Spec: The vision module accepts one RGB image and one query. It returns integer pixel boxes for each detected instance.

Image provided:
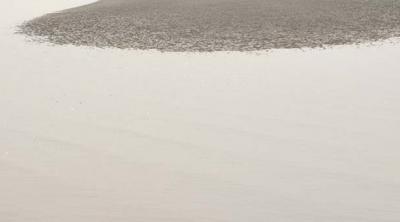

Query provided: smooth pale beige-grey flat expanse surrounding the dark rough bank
[0,0,400,222]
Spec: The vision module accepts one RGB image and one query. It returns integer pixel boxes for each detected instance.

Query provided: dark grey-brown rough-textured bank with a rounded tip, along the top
[20,0,400,51]
